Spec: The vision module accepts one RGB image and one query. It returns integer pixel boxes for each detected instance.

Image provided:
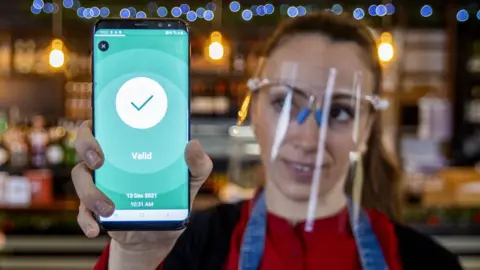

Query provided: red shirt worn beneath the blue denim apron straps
[94,203,402,270]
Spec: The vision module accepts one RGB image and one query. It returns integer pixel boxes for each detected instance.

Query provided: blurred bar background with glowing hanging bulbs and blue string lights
[0,0,480,270]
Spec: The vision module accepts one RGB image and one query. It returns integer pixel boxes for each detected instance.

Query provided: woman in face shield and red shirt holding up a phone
[72,13,461,270]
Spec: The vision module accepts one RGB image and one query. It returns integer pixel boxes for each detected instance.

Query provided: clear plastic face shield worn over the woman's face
[229,59,388,231]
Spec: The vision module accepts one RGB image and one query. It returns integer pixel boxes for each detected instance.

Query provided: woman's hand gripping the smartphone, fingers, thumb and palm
[72,121,213,243]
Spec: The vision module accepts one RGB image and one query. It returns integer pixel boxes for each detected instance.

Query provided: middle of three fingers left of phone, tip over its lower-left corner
[72,162,115,217]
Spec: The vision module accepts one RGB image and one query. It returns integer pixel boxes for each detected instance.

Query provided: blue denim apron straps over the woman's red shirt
[238,192,388,270]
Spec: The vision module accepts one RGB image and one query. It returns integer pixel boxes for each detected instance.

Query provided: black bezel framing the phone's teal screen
[91,18,192,231]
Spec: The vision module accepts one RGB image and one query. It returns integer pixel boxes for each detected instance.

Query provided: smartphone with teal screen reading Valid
[92,19,190,231]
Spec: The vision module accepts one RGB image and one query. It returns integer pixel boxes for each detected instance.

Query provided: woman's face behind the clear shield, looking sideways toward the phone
[251,34,374,201]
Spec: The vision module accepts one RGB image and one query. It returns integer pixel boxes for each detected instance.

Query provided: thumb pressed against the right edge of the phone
[185,140,213,197]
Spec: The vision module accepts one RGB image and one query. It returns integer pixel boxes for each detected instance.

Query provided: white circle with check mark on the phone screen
[116,77,168,129]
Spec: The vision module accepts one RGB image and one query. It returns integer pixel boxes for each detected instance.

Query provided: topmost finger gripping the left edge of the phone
[75,121,103,170]
